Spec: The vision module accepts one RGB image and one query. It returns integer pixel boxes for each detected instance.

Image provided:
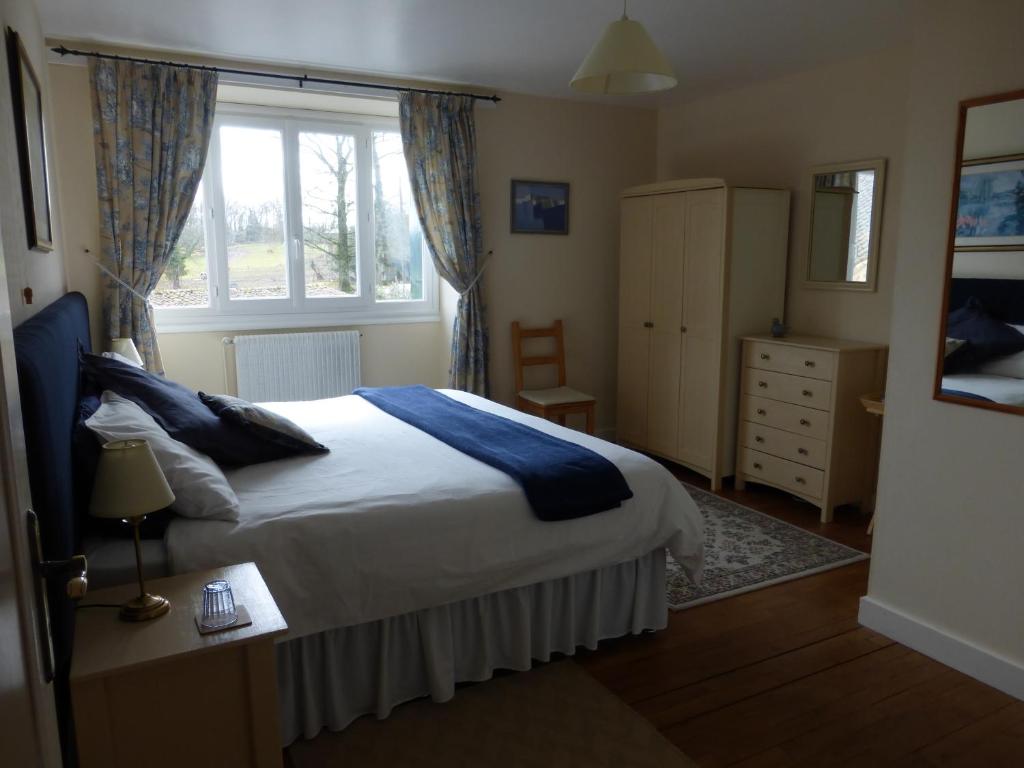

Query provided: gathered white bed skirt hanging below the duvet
[278,549,668,744]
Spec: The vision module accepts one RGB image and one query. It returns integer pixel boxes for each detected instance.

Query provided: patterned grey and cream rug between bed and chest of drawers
[666,483,868,610]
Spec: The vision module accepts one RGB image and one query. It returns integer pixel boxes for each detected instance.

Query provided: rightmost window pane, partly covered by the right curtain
[371,131,424,301]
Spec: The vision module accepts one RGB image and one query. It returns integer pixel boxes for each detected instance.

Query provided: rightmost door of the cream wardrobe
[677,189,725,471]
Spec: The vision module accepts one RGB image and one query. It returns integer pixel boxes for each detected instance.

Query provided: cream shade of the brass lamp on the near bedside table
[89,440,174,519]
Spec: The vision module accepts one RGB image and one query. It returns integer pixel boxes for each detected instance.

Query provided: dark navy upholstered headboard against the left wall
[14,293,90,696]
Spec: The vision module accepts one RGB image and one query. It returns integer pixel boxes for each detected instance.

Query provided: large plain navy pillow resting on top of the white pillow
[80,353,292,467]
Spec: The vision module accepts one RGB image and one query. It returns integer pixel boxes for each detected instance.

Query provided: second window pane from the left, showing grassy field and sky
[220,125,288,299]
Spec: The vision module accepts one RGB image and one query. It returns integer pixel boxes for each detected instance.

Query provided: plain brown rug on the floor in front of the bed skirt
[285,659,696,768]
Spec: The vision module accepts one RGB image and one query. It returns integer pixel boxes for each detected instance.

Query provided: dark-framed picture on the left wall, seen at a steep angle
[7,27,53,251]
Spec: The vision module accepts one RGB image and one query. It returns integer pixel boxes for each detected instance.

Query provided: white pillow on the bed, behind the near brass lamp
[85,391,239,520]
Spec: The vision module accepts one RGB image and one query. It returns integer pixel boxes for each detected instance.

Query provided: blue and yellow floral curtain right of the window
[399,92,489,397]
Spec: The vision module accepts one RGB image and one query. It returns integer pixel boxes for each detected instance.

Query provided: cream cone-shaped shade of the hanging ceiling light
[569,14,678,94]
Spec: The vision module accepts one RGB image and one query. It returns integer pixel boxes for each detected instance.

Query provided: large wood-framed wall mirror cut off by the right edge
[935,91,1024,414]
